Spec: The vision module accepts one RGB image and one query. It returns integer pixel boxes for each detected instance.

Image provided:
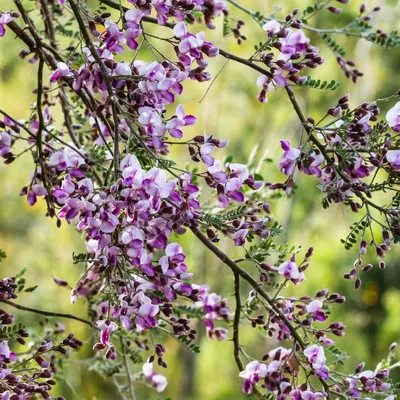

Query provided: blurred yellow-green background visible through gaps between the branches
[0,0,400,400]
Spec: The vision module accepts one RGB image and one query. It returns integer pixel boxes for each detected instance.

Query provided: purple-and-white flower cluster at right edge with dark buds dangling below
[270,95,400,282]
